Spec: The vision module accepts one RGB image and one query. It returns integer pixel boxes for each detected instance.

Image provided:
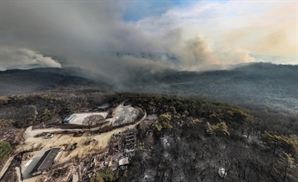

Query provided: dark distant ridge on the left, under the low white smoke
[0,68,94,96]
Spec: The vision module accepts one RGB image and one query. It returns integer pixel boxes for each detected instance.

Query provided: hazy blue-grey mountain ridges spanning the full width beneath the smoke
[0,63,298,112]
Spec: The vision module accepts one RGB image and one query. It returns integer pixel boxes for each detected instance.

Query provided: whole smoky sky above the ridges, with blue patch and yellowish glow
[0,0,297,75]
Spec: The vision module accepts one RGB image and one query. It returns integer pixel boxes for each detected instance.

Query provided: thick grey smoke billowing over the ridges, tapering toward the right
[0,1,254,78]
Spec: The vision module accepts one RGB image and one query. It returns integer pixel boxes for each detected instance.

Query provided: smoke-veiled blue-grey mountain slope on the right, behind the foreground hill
[121,63,298,113]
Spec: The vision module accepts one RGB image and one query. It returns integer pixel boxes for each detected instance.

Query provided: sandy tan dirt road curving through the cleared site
[24,104,147,163]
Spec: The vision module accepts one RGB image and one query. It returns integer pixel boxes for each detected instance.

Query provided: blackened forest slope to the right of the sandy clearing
[114,94,298,182]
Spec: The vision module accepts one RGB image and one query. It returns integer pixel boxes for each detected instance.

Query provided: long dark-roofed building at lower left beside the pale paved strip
[30,148,60,176]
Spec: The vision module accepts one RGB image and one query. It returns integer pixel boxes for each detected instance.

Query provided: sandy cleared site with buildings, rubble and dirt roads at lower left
[0,103,147,182]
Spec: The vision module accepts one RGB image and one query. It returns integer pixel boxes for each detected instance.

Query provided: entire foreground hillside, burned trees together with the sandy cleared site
[1,92,298,182]
